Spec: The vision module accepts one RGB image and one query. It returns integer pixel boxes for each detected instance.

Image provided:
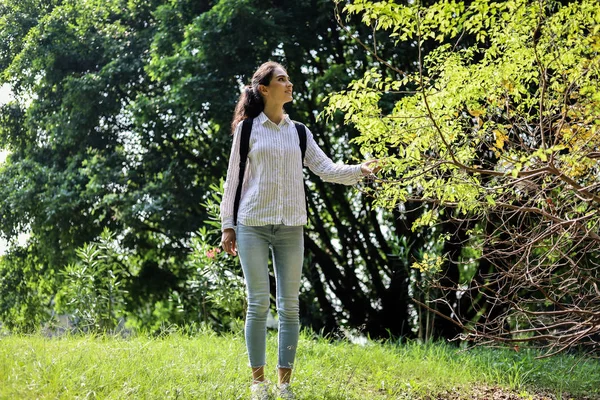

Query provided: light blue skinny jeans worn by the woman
[236,225,304,368]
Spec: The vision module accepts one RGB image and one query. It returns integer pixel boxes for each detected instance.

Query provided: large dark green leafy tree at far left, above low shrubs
[0,1,213,330]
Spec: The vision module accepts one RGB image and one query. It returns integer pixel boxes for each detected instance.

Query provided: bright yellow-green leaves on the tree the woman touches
[326,0,600,225]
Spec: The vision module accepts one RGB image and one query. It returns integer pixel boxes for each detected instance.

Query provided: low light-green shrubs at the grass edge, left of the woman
[49,185,245,332]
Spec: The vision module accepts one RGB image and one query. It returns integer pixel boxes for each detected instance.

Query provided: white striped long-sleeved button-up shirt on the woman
[221,113,362,230]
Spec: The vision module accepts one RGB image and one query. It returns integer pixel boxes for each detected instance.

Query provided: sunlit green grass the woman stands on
[0,333,600,400]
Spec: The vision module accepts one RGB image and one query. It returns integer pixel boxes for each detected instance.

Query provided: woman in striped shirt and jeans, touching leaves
[221,62,379,399]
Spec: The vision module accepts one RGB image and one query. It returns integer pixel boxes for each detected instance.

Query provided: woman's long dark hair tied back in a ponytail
[231,61,285,133]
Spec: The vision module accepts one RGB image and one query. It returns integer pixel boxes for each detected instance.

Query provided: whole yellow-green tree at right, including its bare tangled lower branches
[327,0,600,351]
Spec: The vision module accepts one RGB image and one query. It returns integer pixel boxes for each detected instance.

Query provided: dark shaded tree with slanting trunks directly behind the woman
[153,1,422,337]
